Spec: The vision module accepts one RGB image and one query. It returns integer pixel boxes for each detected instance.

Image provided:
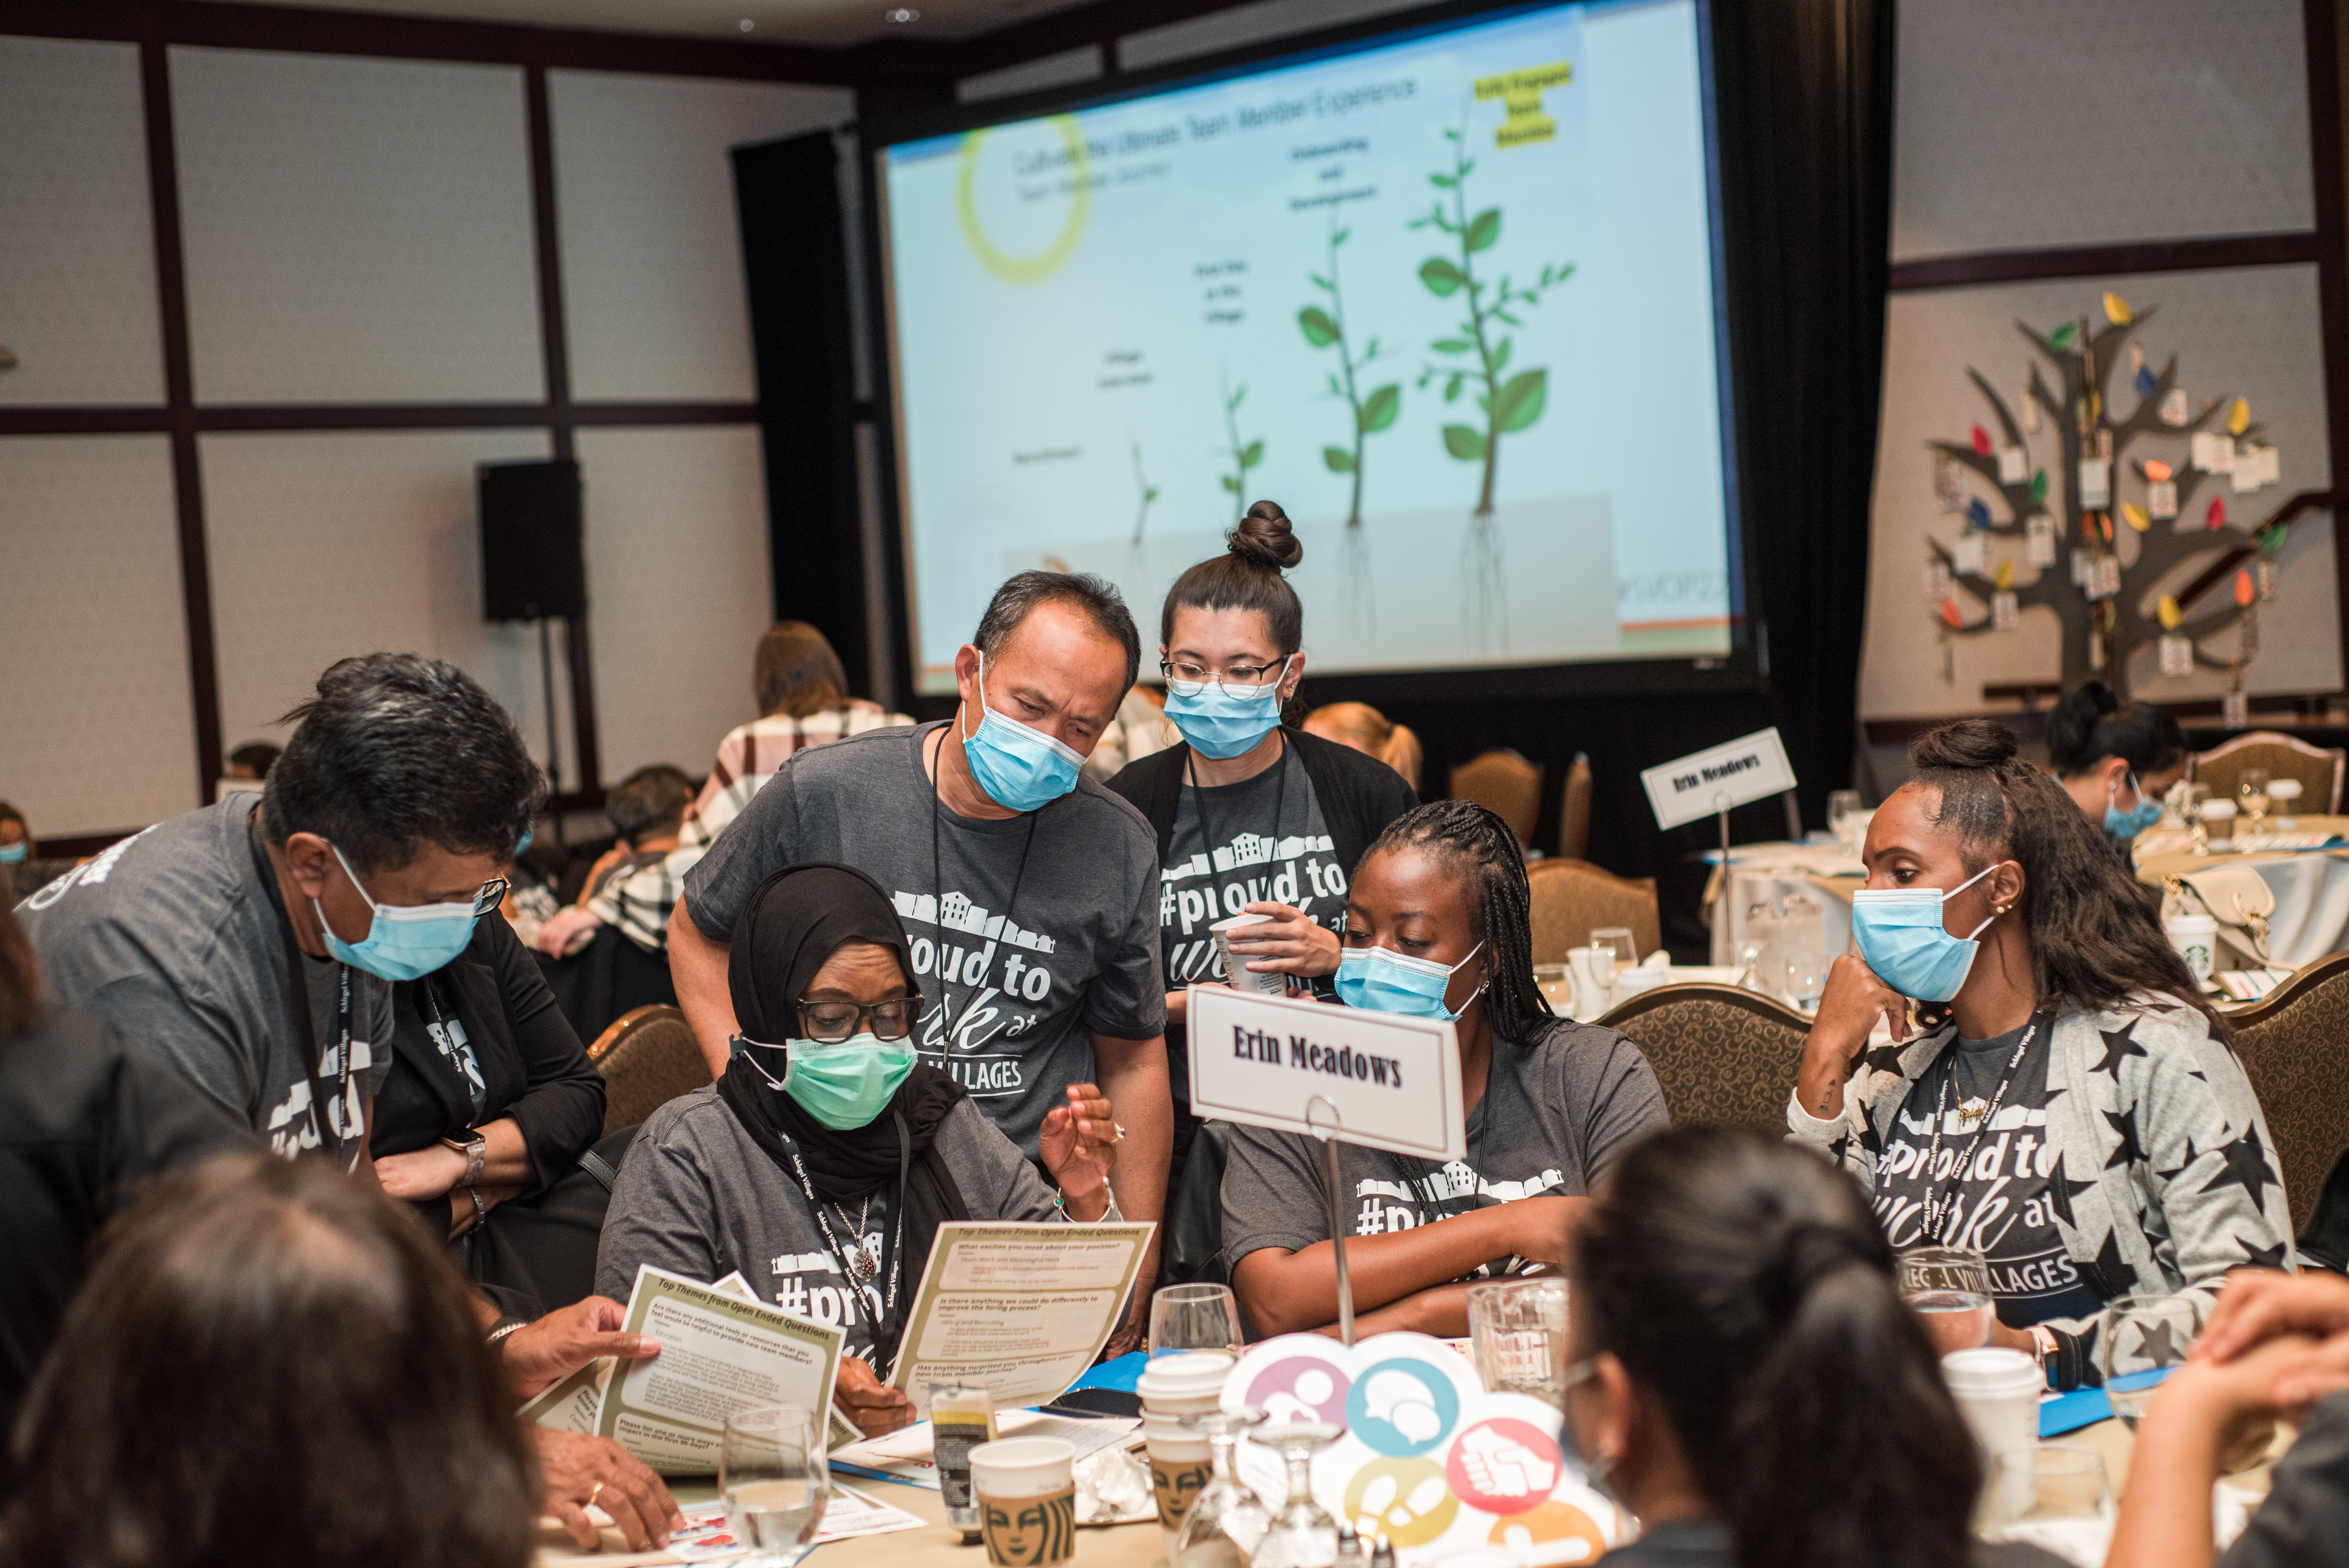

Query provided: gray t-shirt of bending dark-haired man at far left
[16,793,392,1162]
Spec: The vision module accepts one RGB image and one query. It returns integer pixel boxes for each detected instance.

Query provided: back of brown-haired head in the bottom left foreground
[0,1155,540,1568]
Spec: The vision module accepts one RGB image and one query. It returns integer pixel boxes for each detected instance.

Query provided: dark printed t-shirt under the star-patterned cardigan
[1877,1023,2105,1329]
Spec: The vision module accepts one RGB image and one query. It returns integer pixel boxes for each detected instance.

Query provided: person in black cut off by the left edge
[0,904,251,1498]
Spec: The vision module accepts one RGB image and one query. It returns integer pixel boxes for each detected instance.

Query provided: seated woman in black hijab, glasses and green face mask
[597,861,1121,1436]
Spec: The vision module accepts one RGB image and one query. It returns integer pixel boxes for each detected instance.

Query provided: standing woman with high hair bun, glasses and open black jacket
[1109,500,1419,1192]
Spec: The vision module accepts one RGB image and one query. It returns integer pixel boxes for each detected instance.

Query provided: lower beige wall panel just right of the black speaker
[578,427,775,784]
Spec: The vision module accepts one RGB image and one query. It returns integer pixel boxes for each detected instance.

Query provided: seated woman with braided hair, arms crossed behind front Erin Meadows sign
[1224,800,1668,1336]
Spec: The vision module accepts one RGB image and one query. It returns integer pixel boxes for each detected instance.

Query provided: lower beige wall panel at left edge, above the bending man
[0,437,197,838]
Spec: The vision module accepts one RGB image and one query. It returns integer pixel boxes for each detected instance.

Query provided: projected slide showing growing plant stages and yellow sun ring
[879,0,1734,693]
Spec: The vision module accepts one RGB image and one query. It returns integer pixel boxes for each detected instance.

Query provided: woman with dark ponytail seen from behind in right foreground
[1565,1127,2058,1568]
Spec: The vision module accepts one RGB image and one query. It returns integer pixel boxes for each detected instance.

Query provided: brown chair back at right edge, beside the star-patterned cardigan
[2231,953,2349,1232]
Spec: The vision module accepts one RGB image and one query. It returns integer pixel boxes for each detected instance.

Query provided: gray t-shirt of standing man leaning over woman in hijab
[686,725,1165,1155]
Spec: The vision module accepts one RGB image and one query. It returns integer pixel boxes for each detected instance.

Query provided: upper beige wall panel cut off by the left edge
[0,37,162,406]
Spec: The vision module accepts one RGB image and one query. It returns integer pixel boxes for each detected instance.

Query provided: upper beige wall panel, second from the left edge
[171,47,545,404]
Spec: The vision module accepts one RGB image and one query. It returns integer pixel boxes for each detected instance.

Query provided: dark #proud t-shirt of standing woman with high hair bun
[1158,747,1346,1106]
